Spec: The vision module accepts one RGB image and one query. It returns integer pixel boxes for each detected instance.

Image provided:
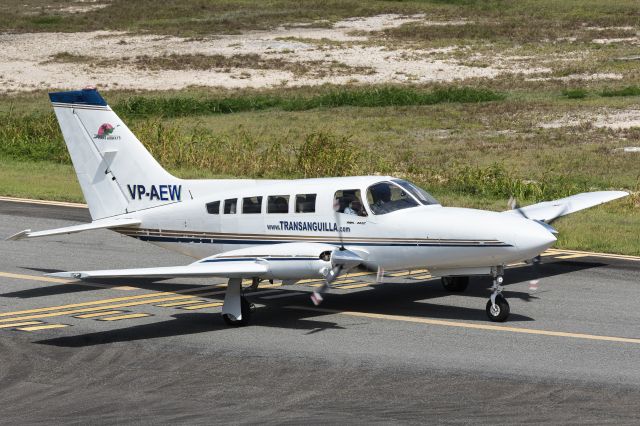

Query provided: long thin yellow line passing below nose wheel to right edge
[287,306,640,344]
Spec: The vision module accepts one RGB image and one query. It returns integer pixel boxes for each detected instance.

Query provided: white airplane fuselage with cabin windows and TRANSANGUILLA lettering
[118,176,555,274]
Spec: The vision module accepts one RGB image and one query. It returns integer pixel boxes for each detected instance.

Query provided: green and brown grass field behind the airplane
[0,0,640,255]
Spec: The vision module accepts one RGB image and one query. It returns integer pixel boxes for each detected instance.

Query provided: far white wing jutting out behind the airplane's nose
[504,191,629,223]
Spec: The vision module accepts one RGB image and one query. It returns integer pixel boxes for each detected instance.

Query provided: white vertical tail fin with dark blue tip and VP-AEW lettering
[49,89,185,220]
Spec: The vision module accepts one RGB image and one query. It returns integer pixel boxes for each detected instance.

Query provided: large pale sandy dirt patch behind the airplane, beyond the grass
[0,13,628,93]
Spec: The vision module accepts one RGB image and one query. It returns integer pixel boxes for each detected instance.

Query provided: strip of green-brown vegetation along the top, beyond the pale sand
[0,0,640,36]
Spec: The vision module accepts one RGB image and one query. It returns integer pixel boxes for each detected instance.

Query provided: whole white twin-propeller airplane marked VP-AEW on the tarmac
[9,88,628,325]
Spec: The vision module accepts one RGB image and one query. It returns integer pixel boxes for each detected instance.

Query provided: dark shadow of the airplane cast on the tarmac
[23,262,602,347]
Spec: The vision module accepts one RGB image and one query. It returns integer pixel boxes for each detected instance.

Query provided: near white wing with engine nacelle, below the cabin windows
[47,243,364,280]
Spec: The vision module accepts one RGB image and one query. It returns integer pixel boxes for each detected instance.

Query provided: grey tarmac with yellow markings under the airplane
[0,200,640,425]
